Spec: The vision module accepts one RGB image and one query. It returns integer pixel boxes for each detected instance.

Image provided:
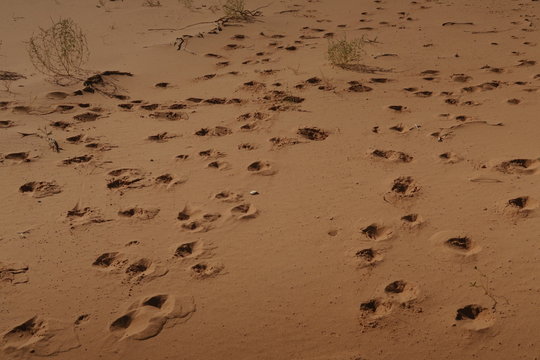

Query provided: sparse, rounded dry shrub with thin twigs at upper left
[28,19,89,82]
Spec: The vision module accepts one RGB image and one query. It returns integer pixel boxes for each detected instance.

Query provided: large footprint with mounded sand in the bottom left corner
[1,316,80,358]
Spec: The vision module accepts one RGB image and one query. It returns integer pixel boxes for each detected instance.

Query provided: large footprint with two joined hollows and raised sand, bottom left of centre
[109,294,195,341]
